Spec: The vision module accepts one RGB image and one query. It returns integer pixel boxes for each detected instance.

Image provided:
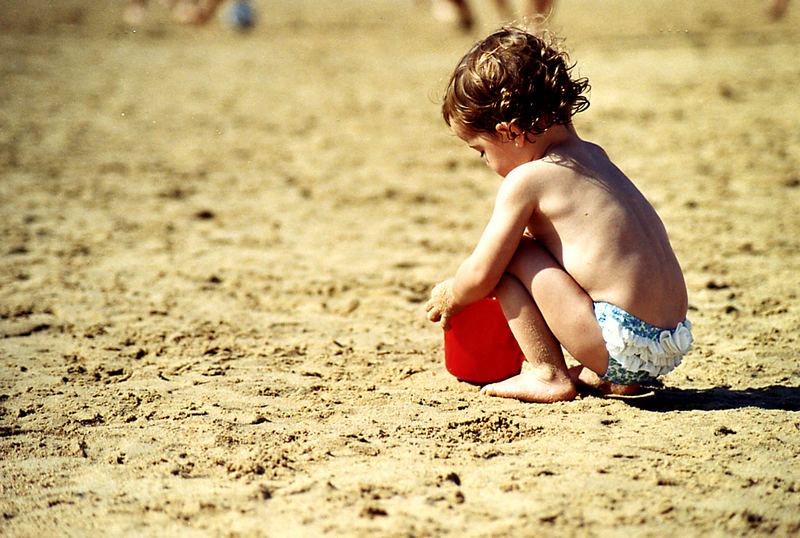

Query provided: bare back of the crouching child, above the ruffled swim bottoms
[519,132,688,329]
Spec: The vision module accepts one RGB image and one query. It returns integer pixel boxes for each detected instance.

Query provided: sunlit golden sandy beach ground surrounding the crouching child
[0,0,800,537]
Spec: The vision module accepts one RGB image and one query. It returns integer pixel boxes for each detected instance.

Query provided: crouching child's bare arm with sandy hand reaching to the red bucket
[426,168,536,329]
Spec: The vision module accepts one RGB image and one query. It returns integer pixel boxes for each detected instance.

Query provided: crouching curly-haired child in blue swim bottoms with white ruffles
[426,28,692,402]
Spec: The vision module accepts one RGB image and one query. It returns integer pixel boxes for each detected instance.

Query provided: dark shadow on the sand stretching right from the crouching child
[627,385,800,412]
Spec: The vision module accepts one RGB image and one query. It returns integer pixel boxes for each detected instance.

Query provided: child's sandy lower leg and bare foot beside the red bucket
[481,274,577,402]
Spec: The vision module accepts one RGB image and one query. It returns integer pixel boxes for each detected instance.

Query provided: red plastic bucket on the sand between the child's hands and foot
[444,297,525,384]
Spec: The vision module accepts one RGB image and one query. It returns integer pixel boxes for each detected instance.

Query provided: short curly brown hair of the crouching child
[442,28,590,135]
